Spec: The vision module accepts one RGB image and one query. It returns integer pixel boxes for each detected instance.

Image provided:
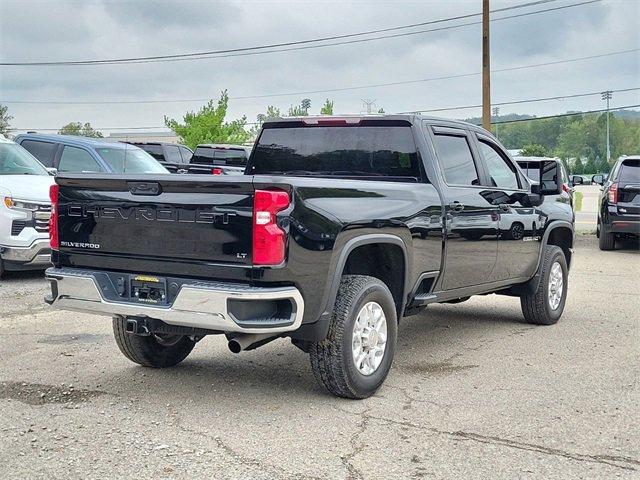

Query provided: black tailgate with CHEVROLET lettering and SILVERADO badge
[57,175,253,265]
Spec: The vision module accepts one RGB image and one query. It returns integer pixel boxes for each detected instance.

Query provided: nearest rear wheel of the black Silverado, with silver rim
[309,275,398,399]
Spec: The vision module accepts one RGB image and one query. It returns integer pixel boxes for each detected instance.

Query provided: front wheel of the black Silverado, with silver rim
[520,245,569,325]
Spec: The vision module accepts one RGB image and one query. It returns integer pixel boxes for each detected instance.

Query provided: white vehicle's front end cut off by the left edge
[0,135,54,275]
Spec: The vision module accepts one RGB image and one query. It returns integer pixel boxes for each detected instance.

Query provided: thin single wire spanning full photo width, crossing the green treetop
[0,48,640,105]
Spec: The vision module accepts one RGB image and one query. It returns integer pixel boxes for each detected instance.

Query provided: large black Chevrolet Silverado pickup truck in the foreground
[46,115,574,398]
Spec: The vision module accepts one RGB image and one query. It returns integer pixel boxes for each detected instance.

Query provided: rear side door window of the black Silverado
[434,132,480,186]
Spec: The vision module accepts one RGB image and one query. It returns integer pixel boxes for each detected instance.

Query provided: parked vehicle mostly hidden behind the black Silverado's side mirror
[515,157,582,207]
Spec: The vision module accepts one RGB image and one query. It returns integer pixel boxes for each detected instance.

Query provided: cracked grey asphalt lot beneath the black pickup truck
[0,236,640,479]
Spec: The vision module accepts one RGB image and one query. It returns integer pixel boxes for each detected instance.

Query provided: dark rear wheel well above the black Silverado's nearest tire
[342,243,405,319]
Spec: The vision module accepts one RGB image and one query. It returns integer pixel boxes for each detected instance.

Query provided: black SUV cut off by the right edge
[591,155,640,250]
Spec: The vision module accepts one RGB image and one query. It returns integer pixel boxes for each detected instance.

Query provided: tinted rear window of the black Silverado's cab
[250,125,421,181]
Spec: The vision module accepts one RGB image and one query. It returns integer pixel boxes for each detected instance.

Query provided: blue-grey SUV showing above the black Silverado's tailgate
[15,133,169,174]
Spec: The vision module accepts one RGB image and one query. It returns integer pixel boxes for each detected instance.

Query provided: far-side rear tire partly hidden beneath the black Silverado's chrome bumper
[113,317,195,368]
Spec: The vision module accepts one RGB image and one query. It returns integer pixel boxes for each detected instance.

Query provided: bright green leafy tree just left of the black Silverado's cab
[164,90,251,148]
